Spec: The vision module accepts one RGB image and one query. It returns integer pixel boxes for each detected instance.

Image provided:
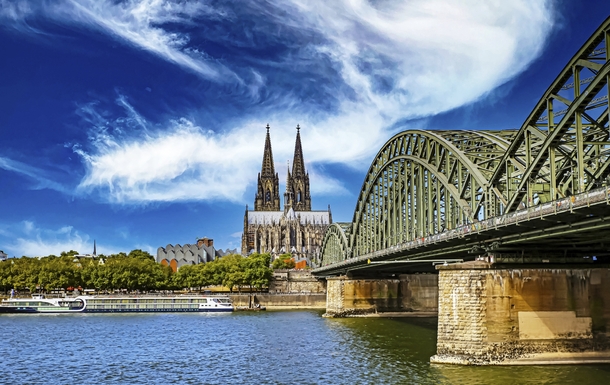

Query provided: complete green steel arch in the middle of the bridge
[342,130,511,263]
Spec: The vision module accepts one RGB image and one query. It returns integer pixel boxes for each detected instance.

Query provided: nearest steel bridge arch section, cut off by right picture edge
[489,18,610,213]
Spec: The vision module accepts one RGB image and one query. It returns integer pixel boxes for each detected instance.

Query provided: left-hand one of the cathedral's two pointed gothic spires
[254,124,280,211]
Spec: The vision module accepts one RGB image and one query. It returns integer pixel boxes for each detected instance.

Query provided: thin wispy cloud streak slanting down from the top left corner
[0,0,241,82]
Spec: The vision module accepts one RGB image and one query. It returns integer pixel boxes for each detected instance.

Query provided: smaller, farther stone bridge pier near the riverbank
[325,274,438,317]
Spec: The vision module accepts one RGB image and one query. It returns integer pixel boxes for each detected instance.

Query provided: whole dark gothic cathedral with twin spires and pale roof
[241,125,332,268]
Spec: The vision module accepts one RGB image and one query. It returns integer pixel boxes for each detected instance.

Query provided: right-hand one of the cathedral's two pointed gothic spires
[284,124,311,211]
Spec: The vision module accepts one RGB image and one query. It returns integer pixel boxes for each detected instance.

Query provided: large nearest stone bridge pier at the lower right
[430,261,610,365]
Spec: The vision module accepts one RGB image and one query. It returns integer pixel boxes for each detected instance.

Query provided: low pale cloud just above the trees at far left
[0,221,119,257]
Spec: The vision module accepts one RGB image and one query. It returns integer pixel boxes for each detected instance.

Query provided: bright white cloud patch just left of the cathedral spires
[75,112,260,203]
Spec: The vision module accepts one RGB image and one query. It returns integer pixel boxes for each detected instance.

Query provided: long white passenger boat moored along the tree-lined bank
[0,295,233,314]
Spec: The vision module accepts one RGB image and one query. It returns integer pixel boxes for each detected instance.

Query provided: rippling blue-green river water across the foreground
[0,311,610,385]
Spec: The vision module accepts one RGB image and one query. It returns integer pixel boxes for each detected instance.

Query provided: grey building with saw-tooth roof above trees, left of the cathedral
[157,238,237,272]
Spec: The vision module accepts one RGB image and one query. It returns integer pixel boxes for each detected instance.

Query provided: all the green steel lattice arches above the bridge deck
[322,18,610,265]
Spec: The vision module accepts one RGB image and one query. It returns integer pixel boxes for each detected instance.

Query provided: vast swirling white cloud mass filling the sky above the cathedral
[5,0,554,204]
